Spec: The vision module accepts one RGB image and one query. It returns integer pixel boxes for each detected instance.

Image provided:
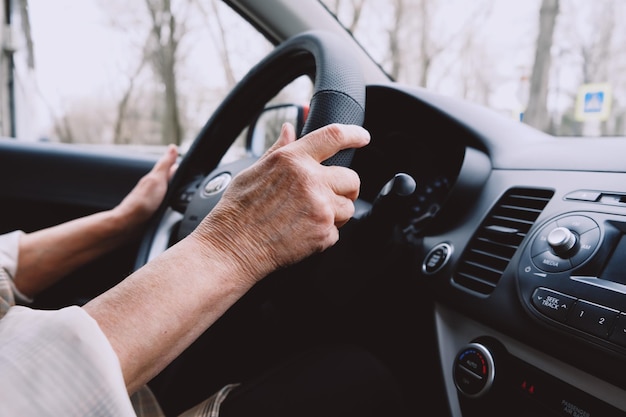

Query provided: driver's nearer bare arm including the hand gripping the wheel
[83,121,369,392]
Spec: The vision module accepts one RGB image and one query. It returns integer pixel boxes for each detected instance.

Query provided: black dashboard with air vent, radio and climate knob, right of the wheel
[353,85,626,416]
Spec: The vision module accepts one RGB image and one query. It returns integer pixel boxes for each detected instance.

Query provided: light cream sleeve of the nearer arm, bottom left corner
[0,306,136,417]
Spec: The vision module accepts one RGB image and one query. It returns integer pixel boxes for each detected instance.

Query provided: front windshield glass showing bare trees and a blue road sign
[321,0,626,136]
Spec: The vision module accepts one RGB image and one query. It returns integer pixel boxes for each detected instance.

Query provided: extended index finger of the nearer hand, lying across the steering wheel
[296,123,370,162]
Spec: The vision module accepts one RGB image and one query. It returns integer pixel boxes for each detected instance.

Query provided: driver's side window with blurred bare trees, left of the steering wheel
[0,0,290,156]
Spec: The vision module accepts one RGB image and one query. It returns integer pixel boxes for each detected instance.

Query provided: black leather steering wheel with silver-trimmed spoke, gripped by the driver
[135,31,365,268]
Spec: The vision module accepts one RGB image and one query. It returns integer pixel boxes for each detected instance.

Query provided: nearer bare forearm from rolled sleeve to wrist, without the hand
[83,234,252,392]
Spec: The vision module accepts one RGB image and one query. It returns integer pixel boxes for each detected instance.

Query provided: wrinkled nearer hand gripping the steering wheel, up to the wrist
[192,124,370,281]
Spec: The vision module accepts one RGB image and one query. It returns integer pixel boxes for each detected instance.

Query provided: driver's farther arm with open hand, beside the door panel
[14,146,177,297]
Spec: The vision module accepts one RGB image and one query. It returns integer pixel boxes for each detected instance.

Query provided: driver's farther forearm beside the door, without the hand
[14,209,143,297]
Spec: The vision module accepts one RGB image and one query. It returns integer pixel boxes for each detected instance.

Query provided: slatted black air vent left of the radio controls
[454,188,554,295]
